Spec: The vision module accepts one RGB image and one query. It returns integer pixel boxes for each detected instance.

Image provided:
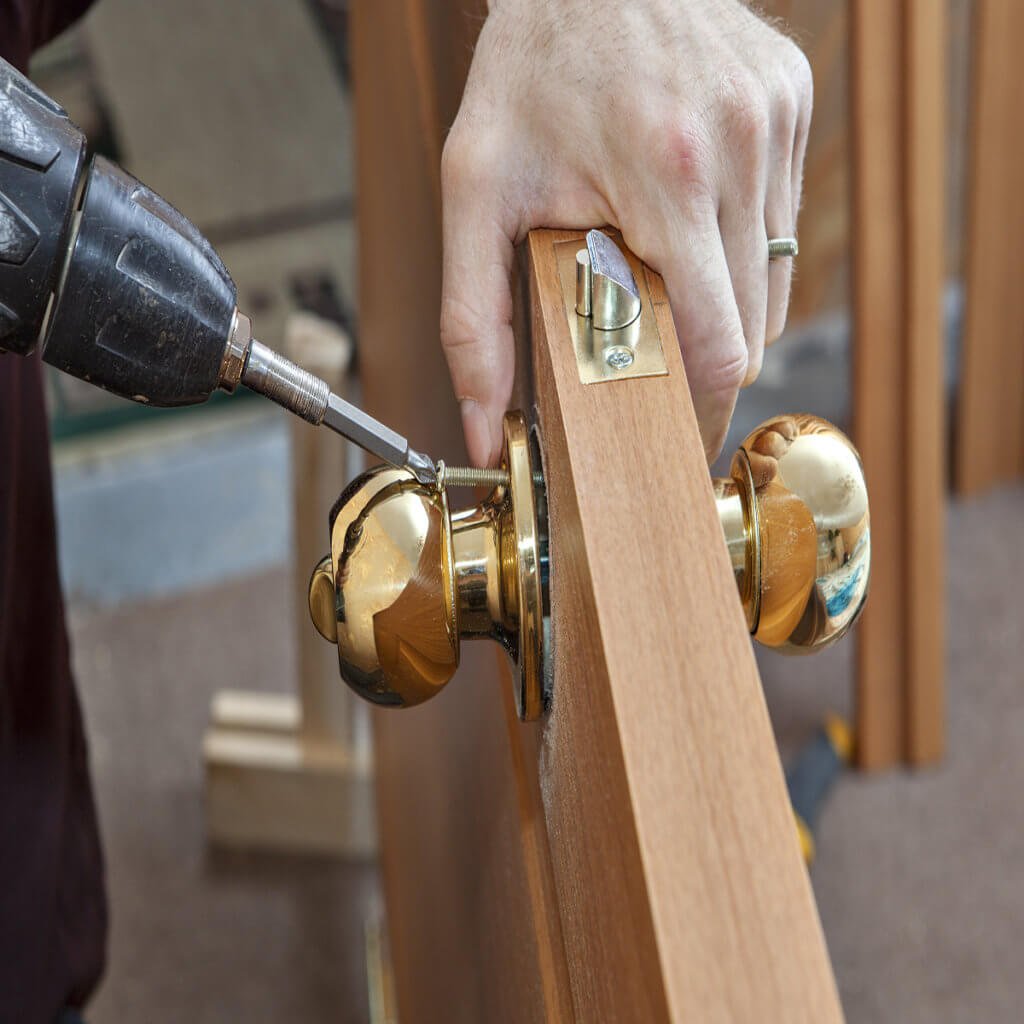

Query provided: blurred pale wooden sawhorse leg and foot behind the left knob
[203,314,376,856]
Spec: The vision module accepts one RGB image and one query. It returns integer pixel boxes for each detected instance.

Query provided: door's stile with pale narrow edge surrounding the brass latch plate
[529,231,841,1021]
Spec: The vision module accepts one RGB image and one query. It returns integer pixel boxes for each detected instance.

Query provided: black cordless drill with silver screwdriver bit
[0,60,436,483]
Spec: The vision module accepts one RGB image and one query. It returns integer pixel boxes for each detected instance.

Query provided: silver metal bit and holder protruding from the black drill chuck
[242,339,437,485]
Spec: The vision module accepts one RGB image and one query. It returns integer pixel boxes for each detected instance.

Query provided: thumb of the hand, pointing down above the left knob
[440,153,515,466]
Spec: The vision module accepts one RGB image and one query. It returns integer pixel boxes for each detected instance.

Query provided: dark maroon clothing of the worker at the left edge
[0,0,106,1022]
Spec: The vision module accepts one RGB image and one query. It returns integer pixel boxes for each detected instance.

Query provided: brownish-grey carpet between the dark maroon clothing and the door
[72,572,378,1024]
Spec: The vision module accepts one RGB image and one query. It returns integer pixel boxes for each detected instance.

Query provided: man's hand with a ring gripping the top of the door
[441,0,812,465]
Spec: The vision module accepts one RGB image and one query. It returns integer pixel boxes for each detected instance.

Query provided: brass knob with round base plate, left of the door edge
[309,413,547,719]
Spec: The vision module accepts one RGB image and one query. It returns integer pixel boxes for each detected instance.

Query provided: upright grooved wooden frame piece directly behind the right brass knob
[850,0,947,769]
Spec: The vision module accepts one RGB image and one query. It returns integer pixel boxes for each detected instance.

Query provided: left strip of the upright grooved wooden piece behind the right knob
[850,0,906,768]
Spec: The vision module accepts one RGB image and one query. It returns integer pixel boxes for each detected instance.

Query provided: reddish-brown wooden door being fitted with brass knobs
[351,0,842,1024]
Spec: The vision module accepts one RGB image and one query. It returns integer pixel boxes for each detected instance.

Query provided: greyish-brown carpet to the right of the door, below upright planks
[761,487,1024,1024]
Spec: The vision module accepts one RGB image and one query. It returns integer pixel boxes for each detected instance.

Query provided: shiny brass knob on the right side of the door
[714,415,871,652]
